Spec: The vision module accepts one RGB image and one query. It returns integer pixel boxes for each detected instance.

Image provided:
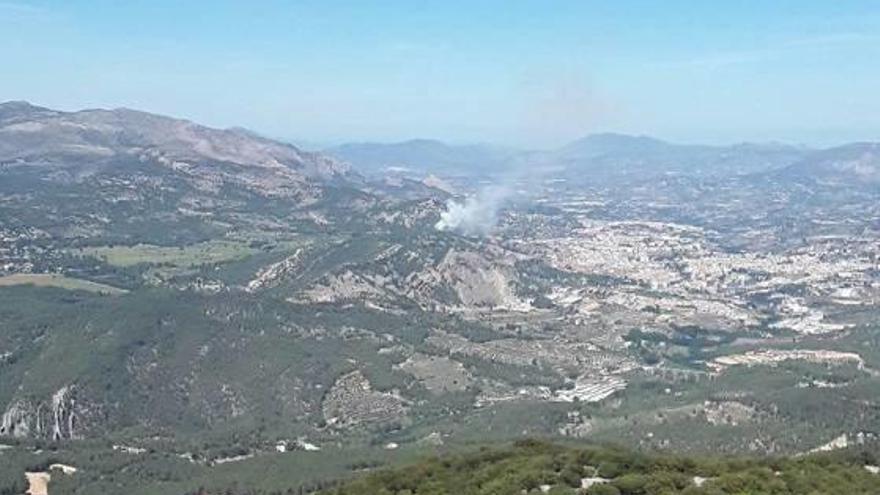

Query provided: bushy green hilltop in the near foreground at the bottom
[324,440,880,495]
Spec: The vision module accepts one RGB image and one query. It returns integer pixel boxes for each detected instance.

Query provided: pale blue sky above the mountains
[0,0,880,147]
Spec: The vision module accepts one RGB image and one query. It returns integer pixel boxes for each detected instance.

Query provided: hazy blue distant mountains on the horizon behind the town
[325,133,878,186]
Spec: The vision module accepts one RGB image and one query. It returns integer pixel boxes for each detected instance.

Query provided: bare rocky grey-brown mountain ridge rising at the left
[0,101,361,211]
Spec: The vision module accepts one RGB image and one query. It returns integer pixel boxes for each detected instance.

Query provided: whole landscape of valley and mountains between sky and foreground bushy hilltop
[0,103,880,495]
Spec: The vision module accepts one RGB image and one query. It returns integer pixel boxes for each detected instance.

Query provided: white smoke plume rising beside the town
[434,186,512,236]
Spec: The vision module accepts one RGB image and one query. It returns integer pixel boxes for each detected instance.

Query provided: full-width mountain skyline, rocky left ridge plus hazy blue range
[0,101,880,198]
